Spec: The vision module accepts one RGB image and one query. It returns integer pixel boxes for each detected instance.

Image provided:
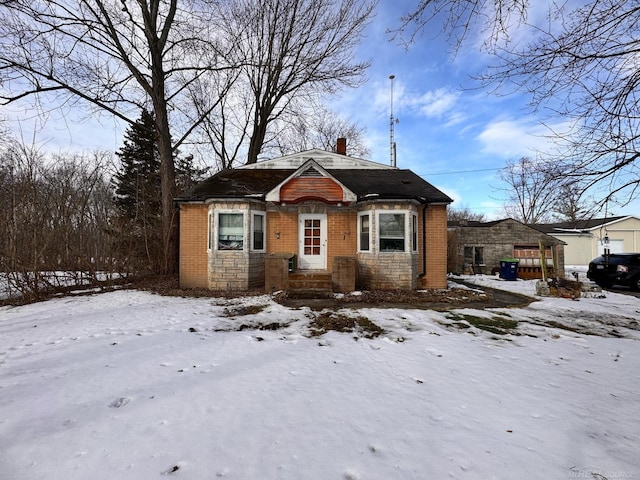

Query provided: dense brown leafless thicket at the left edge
[0,142,114,297]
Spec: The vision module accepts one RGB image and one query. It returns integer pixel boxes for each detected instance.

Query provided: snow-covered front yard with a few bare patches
[0,276,640,480]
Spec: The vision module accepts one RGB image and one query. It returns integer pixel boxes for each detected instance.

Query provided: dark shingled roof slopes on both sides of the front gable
[176,169,453,203]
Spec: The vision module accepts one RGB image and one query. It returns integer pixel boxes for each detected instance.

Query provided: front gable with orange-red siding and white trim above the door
[265,159,358,203]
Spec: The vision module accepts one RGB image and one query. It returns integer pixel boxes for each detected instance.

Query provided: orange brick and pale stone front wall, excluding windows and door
[180,202,447,290]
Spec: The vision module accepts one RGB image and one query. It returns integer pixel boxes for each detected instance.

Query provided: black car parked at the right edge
[587,253,640,290]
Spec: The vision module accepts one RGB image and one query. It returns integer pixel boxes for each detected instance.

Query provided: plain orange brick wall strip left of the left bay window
[179,203,208,288]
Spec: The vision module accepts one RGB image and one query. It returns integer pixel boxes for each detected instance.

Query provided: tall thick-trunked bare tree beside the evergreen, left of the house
[0,0,234,271]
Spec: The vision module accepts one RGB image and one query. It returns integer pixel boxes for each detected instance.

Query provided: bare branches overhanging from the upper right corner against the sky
[484,0,640,212]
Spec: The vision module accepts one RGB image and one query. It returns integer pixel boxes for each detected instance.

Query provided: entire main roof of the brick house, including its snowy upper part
[176,150,453,203]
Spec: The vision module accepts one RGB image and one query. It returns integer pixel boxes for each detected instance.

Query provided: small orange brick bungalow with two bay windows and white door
[176,139,452,291]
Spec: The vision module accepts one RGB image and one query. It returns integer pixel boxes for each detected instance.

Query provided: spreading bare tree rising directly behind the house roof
[217,0,375,163]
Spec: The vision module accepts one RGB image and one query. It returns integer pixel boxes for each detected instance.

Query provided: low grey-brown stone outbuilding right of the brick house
[448,218,564,279]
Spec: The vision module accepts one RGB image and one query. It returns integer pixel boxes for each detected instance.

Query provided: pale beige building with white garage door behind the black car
[534,215,640,265]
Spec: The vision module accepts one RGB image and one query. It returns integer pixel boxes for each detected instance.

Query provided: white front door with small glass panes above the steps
[298,213,327,270]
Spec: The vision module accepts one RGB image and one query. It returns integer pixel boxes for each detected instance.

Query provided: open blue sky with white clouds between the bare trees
[0,0,640,219]
